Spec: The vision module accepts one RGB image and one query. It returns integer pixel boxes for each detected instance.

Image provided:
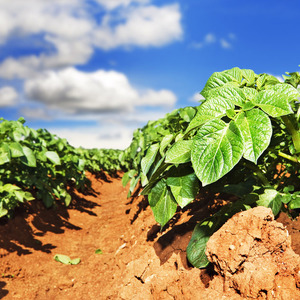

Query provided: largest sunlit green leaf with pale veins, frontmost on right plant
[191,119,244,186]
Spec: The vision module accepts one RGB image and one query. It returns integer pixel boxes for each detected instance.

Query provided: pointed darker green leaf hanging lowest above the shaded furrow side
[148,179,177,227]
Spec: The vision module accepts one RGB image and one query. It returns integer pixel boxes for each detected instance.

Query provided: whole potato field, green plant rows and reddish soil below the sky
[0,68,300,299]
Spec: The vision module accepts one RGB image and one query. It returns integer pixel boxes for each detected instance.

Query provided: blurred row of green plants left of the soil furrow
[0,118,129,217]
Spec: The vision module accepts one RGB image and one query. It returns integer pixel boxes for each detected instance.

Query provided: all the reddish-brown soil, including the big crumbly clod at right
[0,174,300,300]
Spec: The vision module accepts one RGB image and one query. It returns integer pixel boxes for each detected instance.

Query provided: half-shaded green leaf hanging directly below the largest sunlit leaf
[167,168,199,208]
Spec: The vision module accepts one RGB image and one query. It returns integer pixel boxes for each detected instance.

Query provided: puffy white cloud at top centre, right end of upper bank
[94,4,183,50]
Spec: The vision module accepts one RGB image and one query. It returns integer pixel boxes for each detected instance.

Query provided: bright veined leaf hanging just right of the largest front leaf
[235,108,272,164]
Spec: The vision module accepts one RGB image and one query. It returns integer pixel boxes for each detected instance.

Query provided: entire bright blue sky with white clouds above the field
[0,0,300,149]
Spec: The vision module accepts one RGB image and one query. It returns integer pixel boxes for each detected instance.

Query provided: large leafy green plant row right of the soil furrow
[123,68,300,268]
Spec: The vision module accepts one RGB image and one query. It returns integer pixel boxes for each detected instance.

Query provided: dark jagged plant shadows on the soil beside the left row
[0,184,99,257]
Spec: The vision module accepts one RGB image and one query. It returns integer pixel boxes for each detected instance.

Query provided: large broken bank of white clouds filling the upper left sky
[0,0,182,79]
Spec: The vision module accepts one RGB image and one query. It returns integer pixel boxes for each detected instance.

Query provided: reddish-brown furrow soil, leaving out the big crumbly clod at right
[0,175,300,300]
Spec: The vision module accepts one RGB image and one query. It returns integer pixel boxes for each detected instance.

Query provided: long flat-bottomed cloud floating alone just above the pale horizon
[25,67,176,114]
